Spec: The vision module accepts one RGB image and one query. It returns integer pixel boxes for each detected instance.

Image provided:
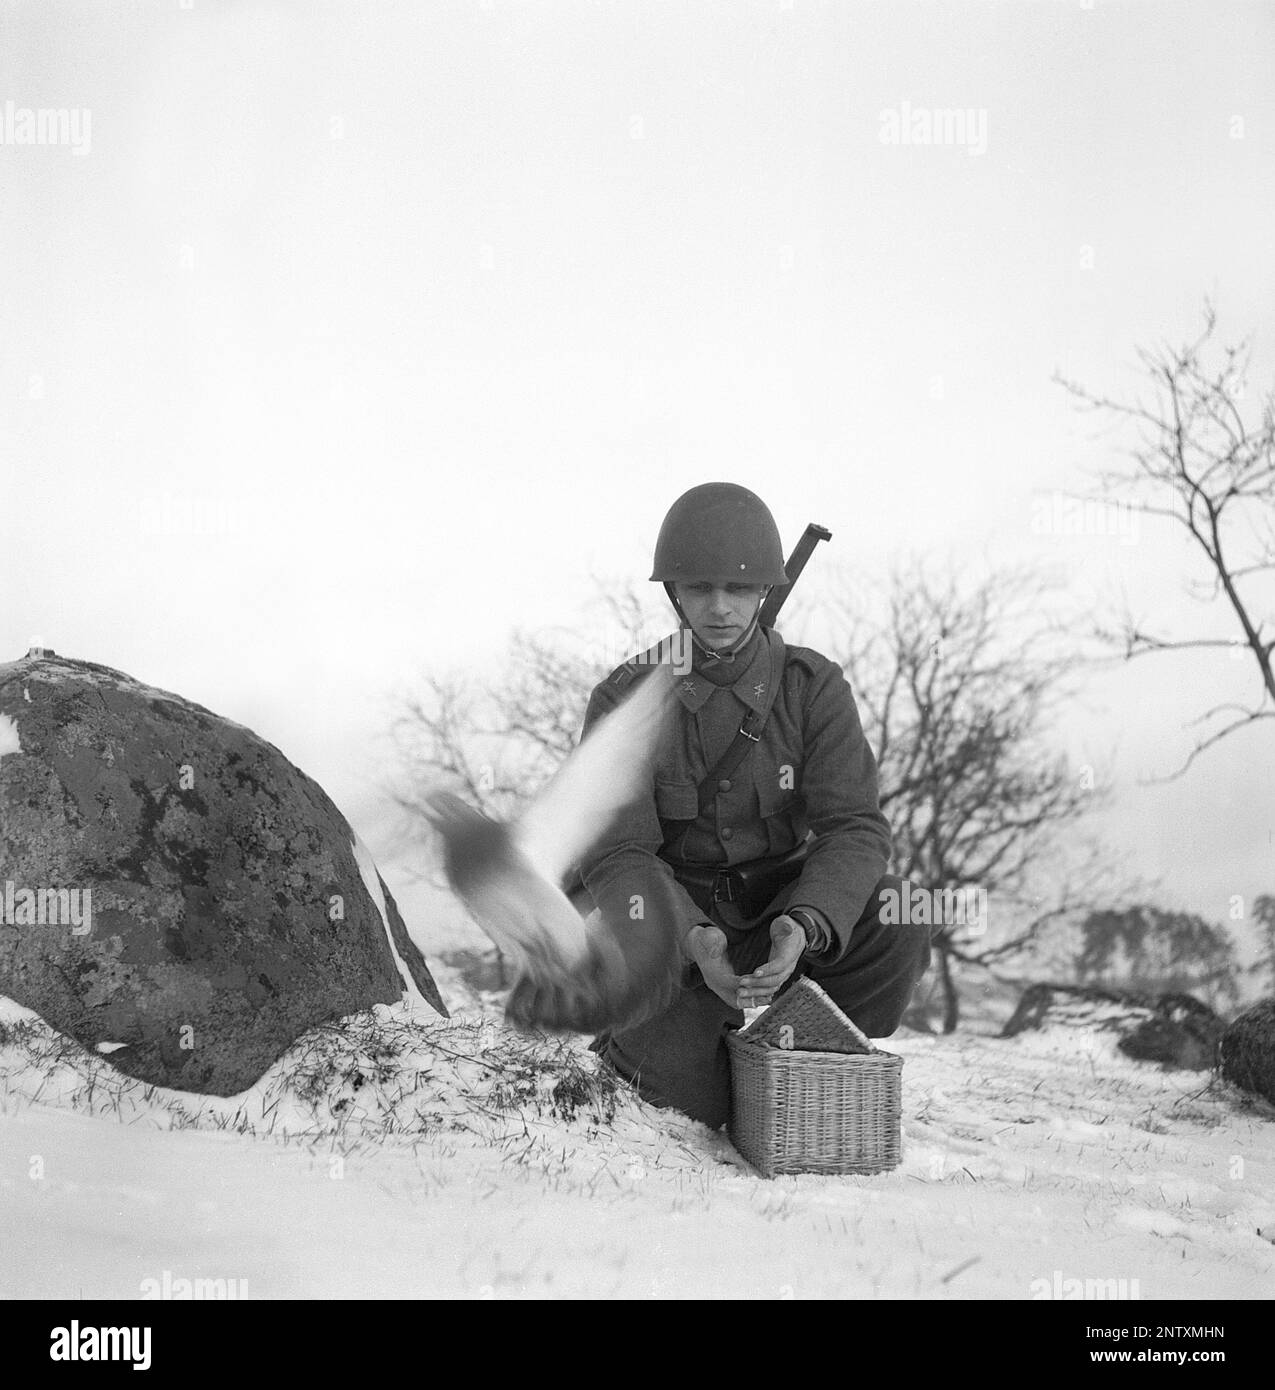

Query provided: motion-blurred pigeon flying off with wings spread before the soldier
[427,664,681,1031]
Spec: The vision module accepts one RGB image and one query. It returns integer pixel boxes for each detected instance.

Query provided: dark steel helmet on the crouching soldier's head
[651,482,788,585]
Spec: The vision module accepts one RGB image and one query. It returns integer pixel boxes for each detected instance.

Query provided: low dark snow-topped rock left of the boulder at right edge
[1001,984,1225,1072]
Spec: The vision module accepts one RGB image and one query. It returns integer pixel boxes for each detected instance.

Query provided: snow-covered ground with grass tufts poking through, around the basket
[0,967,1275,1300]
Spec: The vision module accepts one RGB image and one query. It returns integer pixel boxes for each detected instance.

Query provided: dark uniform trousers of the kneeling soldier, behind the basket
[592,874,930,1129]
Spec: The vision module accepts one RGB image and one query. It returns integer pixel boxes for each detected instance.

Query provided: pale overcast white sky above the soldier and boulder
[0,0,1275,945]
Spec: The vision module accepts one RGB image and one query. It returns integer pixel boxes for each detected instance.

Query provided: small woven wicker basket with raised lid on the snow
[726,991,904,1177]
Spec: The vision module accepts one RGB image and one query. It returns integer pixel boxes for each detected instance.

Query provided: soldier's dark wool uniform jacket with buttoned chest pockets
[580,628,891,954]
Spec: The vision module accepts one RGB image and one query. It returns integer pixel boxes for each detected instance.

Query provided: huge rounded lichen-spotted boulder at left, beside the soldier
[0,649,446,1095]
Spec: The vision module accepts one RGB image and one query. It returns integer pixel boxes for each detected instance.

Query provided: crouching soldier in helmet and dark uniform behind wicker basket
[581,482,930,1127]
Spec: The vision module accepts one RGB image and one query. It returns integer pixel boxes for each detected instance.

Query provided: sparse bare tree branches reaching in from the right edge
[1055,302,1275,776]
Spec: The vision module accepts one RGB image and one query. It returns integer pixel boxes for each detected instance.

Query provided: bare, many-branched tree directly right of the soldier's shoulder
[806,566,1105,1031]
